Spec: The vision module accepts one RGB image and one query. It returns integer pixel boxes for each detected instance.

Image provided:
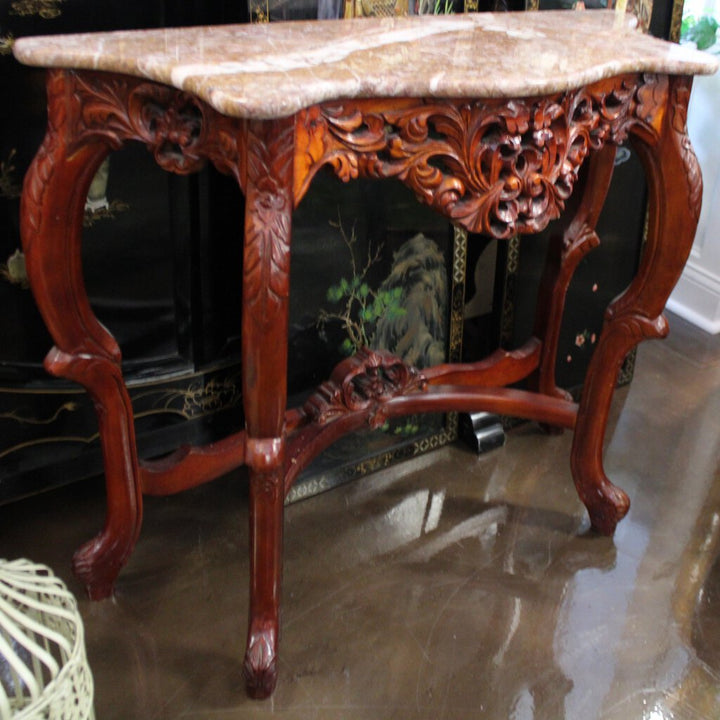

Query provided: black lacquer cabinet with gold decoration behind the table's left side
[0,0,253,502]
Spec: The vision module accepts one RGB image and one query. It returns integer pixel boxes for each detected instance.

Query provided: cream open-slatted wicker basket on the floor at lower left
[0,559,94,720]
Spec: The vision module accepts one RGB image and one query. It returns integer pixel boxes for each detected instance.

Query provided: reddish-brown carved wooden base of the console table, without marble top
[22,70,701,697]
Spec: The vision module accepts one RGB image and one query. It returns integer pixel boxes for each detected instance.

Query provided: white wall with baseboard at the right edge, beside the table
[668,0,720,333]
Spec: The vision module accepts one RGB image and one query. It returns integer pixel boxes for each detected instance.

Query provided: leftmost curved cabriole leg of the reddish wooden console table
[21,71,142,599]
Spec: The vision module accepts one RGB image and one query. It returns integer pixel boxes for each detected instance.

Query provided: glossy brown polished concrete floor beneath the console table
[0,320,720,720]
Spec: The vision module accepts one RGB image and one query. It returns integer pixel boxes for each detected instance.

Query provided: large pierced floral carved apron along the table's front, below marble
[299,75,656,238]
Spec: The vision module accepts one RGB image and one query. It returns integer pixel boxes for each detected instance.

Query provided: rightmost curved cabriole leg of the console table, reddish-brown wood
[571,77,702,535]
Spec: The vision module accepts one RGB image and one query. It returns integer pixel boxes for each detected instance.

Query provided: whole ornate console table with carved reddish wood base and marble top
[14,12,716,697]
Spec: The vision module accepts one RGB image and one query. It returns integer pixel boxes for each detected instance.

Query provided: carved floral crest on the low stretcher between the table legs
[304,348,427,427]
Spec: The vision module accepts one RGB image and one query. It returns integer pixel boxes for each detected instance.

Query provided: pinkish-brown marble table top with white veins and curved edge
[13,10,718,119]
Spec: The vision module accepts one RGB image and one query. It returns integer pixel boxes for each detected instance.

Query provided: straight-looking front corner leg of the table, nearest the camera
[242,119,294,698]
